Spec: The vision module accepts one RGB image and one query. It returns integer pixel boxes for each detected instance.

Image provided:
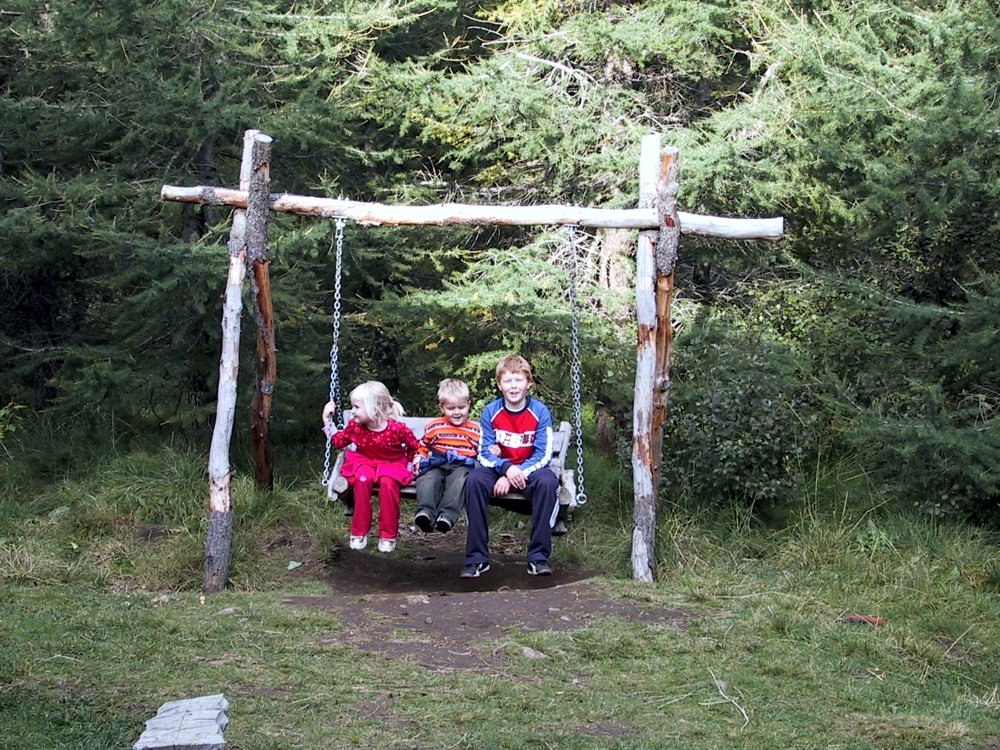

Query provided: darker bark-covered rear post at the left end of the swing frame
[246,135,278,490]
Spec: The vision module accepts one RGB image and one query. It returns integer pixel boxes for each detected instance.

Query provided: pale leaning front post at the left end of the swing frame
[202,130,270,594]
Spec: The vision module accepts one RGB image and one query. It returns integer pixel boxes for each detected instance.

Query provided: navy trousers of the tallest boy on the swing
[465,466,559,565]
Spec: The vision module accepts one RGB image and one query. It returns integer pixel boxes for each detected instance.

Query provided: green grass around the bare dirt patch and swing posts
[0,447,1000,750]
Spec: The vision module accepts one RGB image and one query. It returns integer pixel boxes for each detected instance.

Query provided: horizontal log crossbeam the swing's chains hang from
[160,185,784,240]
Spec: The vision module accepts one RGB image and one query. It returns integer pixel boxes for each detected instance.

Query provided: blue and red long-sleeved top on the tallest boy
[479,396,552,476]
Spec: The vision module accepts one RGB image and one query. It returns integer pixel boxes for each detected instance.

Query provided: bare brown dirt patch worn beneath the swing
[280,526,690,671]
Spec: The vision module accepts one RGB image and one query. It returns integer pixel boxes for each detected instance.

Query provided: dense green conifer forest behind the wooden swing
[0,0,1000,524]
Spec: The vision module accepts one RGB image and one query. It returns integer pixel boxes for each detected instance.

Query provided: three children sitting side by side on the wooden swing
[323,355,559,578]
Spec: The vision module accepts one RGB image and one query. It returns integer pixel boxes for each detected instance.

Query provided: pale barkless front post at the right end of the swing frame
[632,134,660,582]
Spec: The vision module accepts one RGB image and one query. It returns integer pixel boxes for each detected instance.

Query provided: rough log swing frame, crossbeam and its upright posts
[160,131,784,592]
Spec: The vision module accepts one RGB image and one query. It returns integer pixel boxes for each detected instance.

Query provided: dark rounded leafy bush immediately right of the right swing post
[663,316,815,508]
